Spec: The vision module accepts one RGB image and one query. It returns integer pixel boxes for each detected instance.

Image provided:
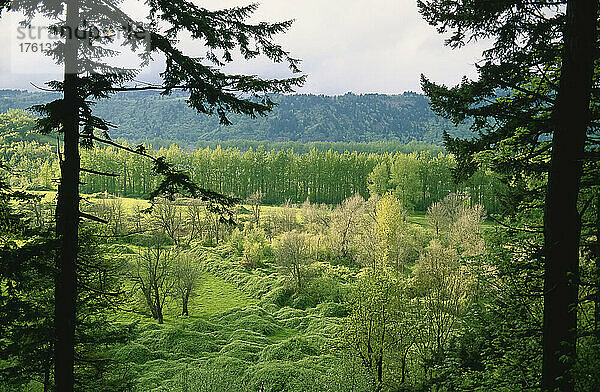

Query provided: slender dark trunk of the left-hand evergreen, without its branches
[54,0,80,392]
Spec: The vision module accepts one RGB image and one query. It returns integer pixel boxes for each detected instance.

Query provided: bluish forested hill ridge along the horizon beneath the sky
[0,90,469,145]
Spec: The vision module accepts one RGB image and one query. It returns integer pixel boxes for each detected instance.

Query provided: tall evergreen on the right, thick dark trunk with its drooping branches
[418,0,598,391]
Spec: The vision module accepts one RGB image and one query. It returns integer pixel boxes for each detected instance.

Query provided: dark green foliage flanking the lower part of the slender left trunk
[0,173,130,392]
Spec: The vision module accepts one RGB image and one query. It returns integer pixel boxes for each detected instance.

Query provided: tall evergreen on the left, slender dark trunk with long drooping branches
[0,0,304,392]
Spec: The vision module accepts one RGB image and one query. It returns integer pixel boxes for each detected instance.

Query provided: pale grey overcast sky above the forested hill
[0,0,488,95]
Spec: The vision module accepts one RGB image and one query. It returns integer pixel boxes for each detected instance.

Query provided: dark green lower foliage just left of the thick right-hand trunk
[429,230,544,392]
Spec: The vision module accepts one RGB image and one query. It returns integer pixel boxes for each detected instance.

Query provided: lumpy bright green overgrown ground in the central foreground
[113,248,364,392]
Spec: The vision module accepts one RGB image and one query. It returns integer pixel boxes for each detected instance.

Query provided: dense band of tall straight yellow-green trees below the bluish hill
[0,110,502,212]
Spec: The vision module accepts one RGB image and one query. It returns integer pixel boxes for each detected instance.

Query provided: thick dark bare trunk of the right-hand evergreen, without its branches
[542,0,598,392]
